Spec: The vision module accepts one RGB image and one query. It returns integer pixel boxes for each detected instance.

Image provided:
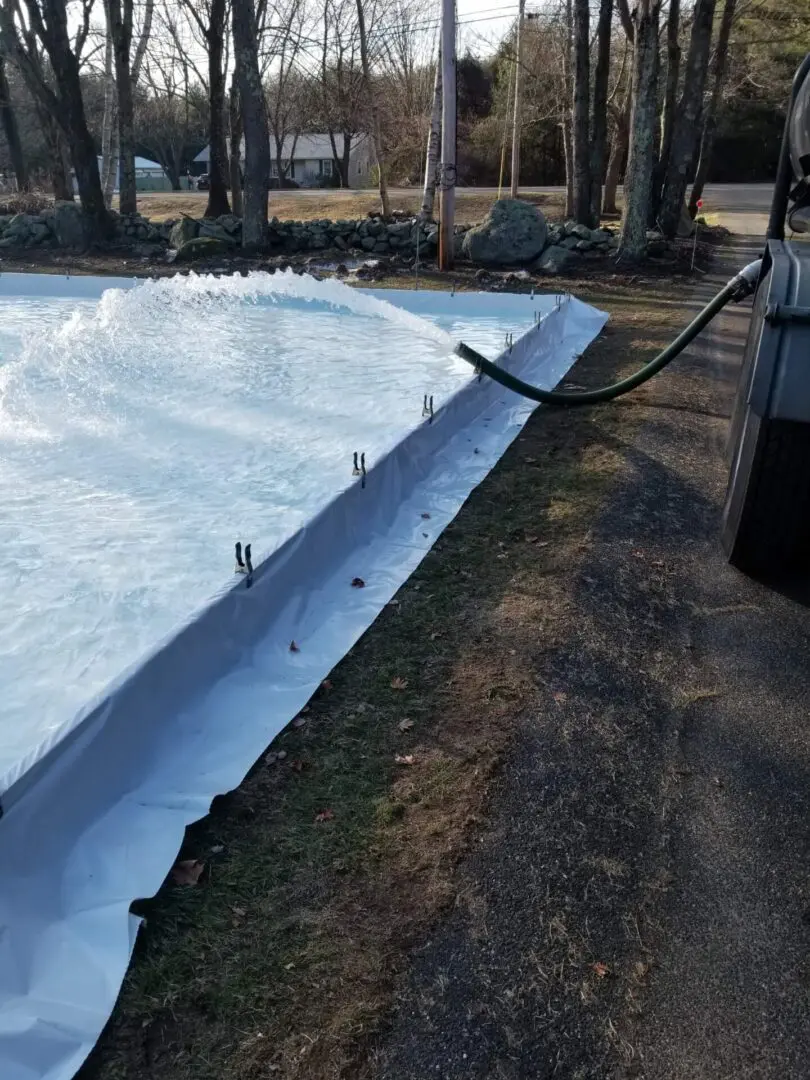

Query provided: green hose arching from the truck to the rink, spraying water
[455,259,762,407]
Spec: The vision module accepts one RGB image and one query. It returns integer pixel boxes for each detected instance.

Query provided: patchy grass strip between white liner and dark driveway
[74,274,686,1080]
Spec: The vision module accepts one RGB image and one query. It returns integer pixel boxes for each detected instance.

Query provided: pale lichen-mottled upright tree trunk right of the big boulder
[619,0,660,259]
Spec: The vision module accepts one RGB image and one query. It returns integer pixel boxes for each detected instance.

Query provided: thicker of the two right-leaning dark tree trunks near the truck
[659,0,715,237]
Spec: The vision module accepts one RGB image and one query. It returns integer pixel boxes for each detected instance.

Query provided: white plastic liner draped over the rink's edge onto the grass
[0,275,606,1080]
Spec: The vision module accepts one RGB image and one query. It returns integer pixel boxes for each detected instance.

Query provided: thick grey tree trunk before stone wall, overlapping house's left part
[233,0,270,247]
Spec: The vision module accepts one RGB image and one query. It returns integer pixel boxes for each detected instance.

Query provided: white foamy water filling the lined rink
[0,265,546,777]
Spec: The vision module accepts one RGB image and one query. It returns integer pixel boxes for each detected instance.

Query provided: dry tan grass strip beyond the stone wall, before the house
[130,190,563,224]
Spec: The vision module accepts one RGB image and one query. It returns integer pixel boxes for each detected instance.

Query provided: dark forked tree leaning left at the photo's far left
[0,0,110,237]
